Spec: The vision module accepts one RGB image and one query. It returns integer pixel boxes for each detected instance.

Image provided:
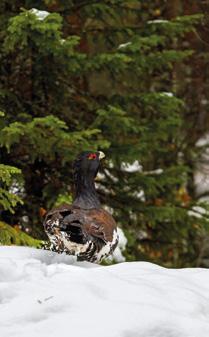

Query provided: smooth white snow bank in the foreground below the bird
[0,247,209,337]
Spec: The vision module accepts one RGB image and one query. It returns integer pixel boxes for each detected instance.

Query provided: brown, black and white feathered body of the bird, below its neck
[44,204,118,262]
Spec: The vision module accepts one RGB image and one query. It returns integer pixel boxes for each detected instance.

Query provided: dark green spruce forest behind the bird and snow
[0,0,209,267]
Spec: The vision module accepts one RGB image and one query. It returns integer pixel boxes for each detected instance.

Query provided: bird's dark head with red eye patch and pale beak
[73,151,105,178]
